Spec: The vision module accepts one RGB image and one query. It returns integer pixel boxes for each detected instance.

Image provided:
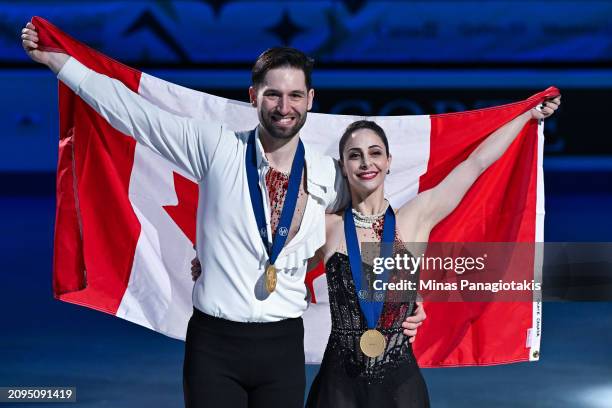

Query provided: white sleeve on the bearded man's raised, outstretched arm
[57,57,223,180]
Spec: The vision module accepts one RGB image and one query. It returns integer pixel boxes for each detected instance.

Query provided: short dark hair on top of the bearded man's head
[251,47,314,90]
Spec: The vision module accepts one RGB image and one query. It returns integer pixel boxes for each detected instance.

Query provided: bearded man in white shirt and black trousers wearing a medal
[22,23,424,408]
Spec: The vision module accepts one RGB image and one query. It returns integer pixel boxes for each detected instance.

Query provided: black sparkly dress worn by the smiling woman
[306,252,429,408]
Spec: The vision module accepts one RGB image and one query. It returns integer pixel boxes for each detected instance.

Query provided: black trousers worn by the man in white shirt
[183,308,306,408]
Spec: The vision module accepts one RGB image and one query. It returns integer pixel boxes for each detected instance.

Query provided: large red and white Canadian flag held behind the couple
[33,17,559,367]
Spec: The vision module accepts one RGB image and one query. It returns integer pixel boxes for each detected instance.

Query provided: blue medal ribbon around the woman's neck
[344,204,395,329]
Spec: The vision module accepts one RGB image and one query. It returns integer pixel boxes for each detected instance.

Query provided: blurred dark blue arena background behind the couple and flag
[0,0,612,407]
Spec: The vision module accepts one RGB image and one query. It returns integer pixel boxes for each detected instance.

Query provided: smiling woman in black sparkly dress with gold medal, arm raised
[306,97,560,408]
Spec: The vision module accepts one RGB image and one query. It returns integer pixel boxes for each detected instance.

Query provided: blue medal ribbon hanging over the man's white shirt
[245,130,304,265]
